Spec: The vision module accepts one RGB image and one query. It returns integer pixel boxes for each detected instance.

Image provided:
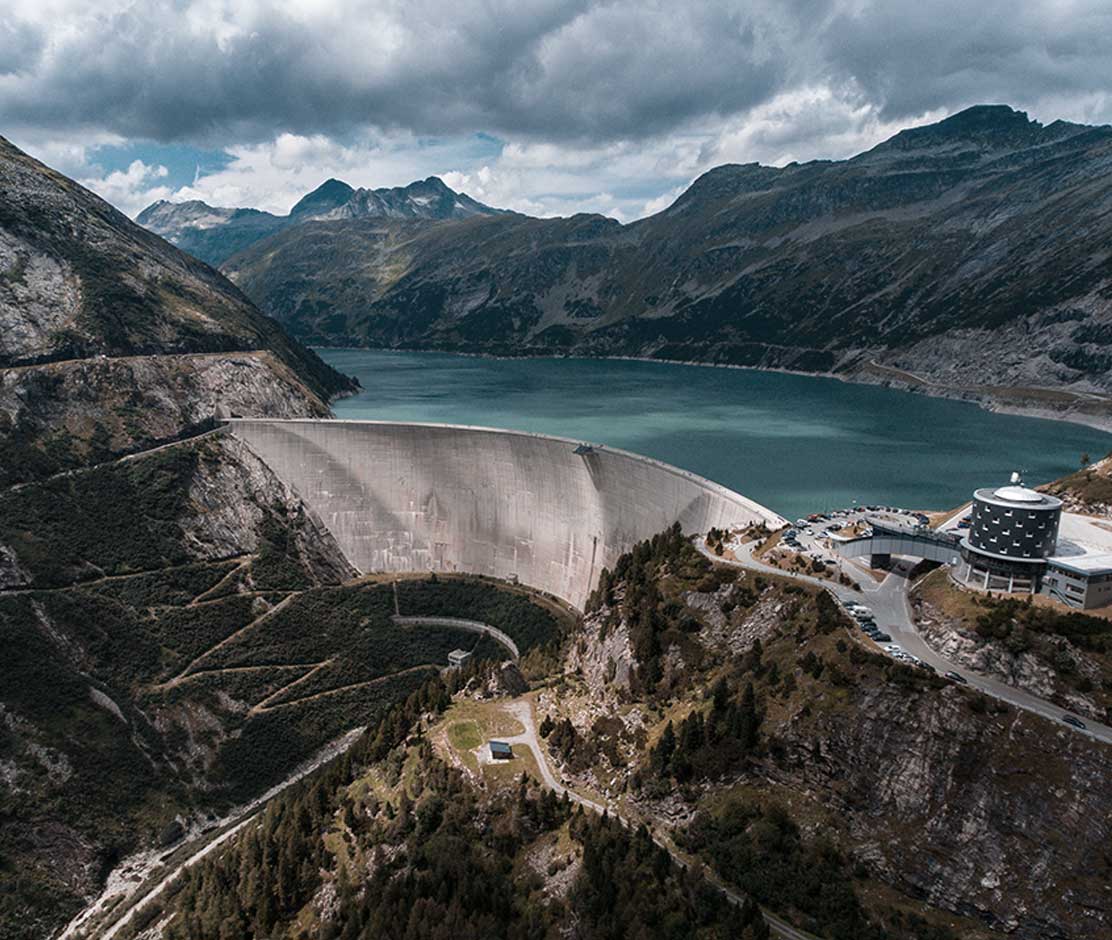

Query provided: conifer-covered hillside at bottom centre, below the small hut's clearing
[123,667,770,940]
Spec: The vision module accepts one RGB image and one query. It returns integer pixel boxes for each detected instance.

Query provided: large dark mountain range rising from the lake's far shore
[140,106,1112,426]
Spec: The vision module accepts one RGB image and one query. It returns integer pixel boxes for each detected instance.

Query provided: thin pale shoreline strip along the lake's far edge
[310,346,1112,436]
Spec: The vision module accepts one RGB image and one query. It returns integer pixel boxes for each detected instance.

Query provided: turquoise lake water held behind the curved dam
[318,349,1112,518]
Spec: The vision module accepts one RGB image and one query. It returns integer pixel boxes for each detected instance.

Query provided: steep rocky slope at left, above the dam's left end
[0,139,353,483]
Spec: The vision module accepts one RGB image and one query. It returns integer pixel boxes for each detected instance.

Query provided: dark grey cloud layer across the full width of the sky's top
[0,0,1112,145]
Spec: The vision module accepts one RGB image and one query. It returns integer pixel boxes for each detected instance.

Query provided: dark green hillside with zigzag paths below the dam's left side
[0,436,567,940]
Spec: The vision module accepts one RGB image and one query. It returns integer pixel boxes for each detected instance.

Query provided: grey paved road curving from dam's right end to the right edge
[698,540,1112,744]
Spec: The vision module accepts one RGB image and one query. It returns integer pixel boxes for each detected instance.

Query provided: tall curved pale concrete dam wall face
[228,418,784,608]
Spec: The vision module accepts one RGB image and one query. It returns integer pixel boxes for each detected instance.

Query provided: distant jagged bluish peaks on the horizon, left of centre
[136,176,503,265]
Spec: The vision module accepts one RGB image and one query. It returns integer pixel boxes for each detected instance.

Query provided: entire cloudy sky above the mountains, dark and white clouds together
[0,0,1112,220]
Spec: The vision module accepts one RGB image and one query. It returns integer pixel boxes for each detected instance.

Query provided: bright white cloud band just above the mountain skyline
[58,88,965,221]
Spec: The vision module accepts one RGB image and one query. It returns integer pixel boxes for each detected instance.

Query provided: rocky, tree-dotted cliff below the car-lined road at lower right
[538,536,1112,940]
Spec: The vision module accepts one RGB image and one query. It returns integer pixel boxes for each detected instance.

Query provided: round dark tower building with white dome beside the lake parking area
[955,475,1062,594]
